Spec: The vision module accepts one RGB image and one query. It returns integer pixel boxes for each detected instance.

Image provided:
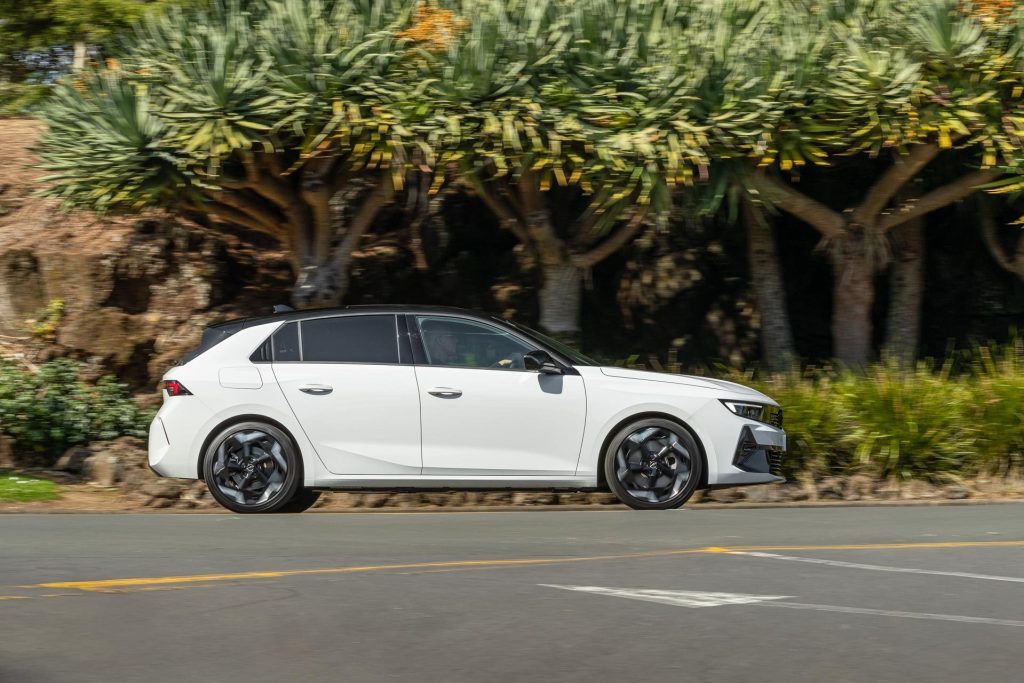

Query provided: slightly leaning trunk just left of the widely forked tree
[741,199,796,372]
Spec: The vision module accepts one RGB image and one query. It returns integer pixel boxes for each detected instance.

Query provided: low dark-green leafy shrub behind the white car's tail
[0,358,152,459]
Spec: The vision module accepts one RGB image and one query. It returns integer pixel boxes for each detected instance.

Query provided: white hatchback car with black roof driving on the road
[150,306,785,512]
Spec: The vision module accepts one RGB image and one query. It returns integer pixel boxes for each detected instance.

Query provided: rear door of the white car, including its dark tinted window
[273,313,422,476]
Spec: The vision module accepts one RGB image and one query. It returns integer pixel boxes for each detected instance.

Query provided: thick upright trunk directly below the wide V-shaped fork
[833,228,874,368]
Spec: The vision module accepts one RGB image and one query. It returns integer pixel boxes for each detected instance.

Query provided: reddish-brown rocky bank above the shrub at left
[0,119,288,390]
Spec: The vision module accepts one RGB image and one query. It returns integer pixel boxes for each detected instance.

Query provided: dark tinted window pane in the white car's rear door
[299,315,398,362]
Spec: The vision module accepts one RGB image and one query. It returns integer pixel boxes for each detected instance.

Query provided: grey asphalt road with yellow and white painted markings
[0,505,1024,683]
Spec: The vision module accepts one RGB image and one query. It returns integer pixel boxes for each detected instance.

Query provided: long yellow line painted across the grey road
[25,541,1024,592]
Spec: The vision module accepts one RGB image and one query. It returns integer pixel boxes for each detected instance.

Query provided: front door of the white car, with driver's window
[413,315,587,477]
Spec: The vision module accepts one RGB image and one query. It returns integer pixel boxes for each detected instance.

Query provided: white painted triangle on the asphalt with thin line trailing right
[538,584,1024,628]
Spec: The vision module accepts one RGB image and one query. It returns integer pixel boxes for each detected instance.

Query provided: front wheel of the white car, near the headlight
[604,418,703,510]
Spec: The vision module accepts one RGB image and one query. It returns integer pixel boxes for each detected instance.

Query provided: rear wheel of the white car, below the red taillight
[203,422,301,514]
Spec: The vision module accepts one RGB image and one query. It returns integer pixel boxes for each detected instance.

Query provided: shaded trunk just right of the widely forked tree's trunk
[886,218,925,364]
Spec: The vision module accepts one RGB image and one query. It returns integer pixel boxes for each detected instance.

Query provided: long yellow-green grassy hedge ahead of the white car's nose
[723,340,1024,480]
